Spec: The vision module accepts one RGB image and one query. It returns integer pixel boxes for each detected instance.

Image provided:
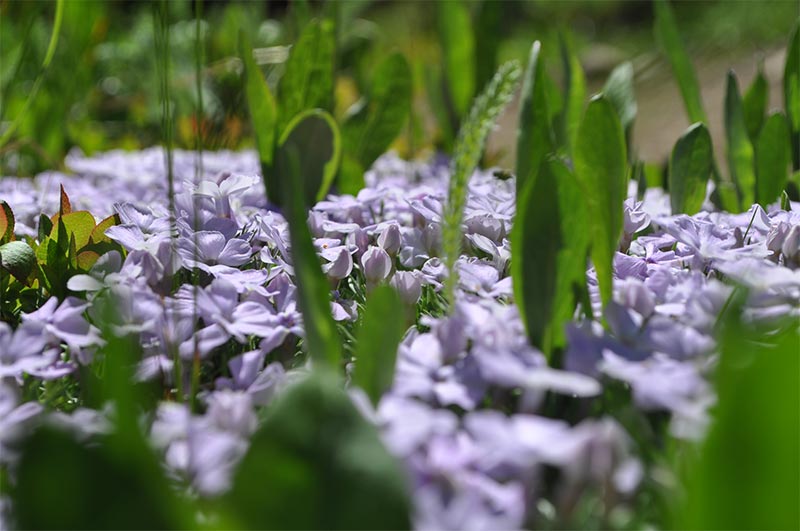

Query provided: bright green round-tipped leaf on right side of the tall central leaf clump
[575,96,628,305]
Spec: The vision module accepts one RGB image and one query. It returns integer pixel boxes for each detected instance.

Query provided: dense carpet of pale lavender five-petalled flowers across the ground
[0,149,800,529]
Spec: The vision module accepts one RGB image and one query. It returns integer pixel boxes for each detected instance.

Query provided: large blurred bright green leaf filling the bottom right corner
[676,312,800,529]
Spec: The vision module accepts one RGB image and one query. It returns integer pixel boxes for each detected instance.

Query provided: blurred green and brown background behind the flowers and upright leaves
[0,0,800,175]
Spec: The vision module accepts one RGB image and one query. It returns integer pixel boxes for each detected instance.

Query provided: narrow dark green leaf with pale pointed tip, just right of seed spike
[516,41,555,195]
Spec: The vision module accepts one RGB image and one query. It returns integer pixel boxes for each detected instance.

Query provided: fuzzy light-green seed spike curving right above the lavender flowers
[442,61,522,301]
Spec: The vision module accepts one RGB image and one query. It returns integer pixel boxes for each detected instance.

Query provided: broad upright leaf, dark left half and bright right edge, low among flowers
[511,161,589,358]
